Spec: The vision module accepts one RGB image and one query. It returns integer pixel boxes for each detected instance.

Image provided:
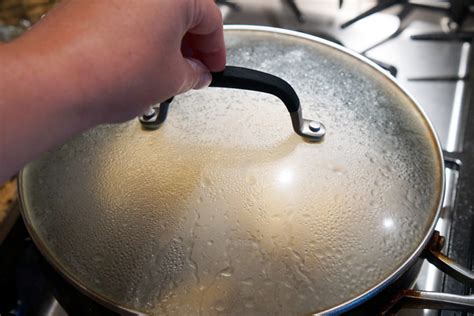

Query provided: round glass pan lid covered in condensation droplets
[20,28,444,315]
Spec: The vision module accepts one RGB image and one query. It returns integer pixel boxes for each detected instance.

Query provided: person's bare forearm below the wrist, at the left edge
[0,38,100,182]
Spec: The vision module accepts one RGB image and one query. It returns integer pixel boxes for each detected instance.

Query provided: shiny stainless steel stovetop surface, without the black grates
[224,1,474,315]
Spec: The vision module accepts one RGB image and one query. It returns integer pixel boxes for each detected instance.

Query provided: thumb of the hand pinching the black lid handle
[180,58,212,93]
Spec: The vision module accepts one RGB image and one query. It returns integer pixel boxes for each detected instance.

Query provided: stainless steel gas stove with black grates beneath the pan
[0,0,474,316]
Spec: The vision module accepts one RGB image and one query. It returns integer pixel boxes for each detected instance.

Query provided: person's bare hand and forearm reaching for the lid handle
[0,0,225,183]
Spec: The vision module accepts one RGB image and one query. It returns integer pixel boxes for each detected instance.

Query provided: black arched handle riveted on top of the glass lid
[140,66,326,141]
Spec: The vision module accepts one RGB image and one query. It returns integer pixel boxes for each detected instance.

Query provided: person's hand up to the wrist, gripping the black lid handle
[14,0,225,125]
